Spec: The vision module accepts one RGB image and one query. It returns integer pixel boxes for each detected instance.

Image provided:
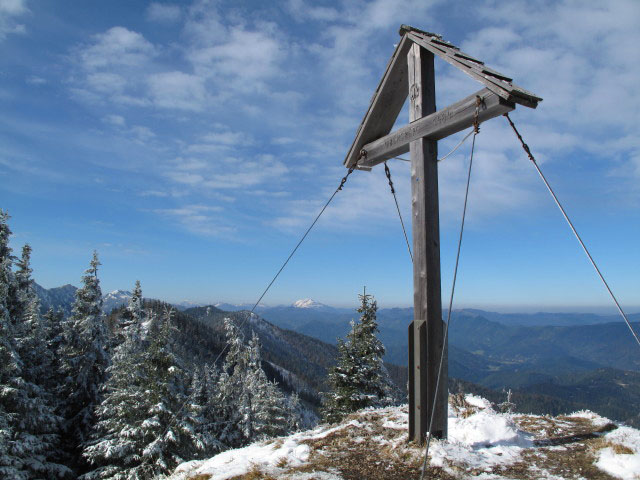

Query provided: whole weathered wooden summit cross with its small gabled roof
[344,25,542,443]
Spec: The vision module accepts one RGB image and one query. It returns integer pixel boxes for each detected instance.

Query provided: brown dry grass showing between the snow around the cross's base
[190,404,633,480]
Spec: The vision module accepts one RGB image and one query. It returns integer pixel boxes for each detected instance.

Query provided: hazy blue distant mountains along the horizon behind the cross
[36,285,640,425]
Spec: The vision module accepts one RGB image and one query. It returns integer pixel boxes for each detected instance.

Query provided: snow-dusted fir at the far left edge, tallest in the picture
[0,210,70,479]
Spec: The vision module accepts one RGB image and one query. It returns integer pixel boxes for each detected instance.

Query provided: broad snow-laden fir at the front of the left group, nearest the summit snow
[82,306,204,480]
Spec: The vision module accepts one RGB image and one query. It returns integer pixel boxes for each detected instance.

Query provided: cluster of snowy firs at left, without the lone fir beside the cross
[0,210,304,480]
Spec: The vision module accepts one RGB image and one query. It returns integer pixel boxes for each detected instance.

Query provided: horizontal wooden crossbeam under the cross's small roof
[356,88,515,170]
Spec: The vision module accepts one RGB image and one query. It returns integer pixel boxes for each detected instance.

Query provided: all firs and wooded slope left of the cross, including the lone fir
[0,210,406,480]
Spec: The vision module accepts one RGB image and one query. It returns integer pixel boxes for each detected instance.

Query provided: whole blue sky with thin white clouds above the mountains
[0,0,640,311]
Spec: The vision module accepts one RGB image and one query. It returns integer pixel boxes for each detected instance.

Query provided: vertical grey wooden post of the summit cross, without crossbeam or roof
[407,44,448,443]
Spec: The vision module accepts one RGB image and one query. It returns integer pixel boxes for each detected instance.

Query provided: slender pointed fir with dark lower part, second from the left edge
[58,252,110,459]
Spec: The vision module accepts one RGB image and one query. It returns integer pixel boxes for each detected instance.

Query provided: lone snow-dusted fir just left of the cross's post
[323,293,394,422]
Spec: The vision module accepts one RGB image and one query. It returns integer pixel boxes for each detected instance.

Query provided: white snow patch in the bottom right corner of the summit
[596,427,640,480]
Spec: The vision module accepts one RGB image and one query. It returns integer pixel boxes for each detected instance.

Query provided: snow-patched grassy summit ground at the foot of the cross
[171,395,640,480]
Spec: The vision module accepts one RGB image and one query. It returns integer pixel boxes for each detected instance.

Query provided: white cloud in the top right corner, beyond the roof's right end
[463,0,640,187]
